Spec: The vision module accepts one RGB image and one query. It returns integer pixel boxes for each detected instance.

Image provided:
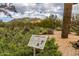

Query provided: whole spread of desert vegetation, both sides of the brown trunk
[0,11,79,56]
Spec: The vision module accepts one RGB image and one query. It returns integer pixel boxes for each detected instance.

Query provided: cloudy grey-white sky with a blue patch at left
[0,3,79,21]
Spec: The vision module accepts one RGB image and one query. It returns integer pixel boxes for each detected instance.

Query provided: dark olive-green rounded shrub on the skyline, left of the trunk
[37,18,62,29]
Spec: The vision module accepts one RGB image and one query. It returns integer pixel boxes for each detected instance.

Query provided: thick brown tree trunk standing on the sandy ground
[61,3,72,38]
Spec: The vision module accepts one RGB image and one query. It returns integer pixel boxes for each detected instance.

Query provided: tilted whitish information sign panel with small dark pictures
[28,35,48,49]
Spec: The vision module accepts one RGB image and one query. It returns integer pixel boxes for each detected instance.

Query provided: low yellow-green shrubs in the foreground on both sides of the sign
[0,27,61,56]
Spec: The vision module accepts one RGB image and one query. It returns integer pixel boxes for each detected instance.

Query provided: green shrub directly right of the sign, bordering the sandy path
[36,38,62,56]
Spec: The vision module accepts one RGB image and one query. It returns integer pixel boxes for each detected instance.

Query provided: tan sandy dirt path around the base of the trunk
[48,31,79,56]
